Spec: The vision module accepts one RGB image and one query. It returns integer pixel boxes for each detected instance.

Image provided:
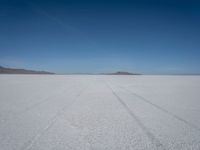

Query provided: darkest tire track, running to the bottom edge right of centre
[104,81,167,150]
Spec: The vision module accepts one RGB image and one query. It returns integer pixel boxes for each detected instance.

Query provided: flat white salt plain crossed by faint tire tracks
[0,75,200,150]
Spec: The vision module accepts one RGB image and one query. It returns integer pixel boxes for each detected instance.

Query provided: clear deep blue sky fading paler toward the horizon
[0,0,200,74]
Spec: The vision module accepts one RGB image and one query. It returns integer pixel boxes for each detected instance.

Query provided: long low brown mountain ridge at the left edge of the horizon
[0,66,54,74]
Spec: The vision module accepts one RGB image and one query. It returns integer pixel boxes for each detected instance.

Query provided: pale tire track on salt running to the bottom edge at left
[21,87,88,150]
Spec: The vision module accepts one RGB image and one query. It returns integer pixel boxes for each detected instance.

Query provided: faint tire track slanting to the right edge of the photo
[119,86,200,131]
